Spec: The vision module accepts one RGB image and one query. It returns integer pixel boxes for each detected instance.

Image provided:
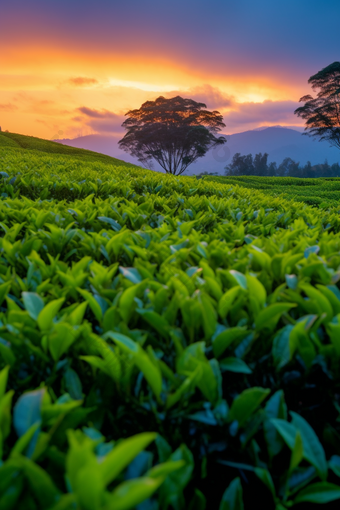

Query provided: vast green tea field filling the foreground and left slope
[0,133,340,510]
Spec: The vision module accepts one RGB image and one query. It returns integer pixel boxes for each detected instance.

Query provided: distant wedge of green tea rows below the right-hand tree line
[204,175,340,209]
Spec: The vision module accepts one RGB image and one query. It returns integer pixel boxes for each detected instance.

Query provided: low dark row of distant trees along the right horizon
[225,152,340,178]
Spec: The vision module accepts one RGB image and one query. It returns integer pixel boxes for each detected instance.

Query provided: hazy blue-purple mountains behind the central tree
[57,127,340,175]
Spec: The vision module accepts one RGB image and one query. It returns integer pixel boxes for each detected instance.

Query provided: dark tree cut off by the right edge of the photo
[294,62,340,149]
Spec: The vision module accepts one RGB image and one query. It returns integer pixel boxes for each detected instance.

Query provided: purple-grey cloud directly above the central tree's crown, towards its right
[165,84,234,110]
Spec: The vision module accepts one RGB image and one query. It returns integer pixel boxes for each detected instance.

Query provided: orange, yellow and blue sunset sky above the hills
[0,0,340,139]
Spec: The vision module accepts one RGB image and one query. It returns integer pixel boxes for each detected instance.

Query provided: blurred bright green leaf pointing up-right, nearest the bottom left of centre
[98,432,157,486]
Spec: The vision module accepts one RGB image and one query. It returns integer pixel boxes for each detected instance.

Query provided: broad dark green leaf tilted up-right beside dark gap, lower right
[228,387,270,426]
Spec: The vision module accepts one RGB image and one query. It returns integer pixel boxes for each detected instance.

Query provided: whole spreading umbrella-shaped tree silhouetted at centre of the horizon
[119,96,226,175]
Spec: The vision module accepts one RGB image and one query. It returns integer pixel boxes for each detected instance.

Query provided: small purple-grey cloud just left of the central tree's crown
[73,106,124,133]
